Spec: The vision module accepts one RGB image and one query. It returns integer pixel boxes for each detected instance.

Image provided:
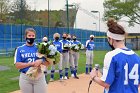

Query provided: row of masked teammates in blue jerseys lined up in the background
[42,33,94,81]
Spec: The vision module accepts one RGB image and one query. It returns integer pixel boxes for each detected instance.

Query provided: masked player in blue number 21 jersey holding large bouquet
[14,28,49,93]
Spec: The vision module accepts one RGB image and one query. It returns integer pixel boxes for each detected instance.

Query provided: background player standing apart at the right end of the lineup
[85,35,95,74]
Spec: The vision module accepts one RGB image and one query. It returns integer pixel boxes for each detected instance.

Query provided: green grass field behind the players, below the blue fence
[0,51,140,93]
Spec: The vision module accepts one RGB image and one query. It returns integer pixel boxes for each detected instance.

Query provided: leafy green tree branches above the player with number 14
[103,0,140,26]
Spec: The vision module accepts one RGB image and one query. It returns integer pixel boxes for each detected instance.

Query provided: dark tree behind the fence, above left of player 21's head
[11,0,29,23]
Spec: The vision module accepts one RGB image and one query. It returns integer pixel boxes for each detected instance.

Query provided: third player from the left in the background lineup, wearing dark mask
[60,33,69,80]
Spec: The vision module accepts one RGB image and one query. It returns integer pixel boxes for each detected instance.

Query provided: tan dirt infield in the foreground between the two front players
[11,74,103,93]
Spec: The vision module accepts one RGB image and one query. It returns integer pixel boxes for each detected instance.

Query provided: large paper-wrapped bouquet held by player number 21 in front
[26,42,60,79]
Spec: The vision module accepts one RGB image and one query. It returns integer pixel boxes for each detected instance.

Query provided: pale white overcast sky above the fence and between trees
[27,0,140,33]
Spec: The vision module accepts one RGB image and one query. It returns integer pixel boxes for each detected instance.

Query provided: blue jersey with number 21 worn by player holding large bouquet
[15,44,38,73]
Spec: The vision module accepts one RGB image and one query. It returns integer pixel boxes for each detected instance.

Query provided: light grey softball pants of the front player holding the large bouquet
[19,73,47,93]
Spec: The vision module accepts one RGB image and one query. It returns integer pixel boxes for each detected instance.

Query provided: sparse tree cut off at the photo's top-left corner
[0,0,9,20]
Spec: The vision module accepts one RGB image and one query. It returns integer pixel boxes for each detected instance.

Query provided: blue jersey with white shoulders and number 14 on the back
[101,48,140,93]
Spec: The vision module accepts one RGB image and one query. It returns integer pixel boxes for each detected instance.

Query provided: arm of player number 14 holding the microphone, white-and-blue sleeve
[90,53,115,88]
